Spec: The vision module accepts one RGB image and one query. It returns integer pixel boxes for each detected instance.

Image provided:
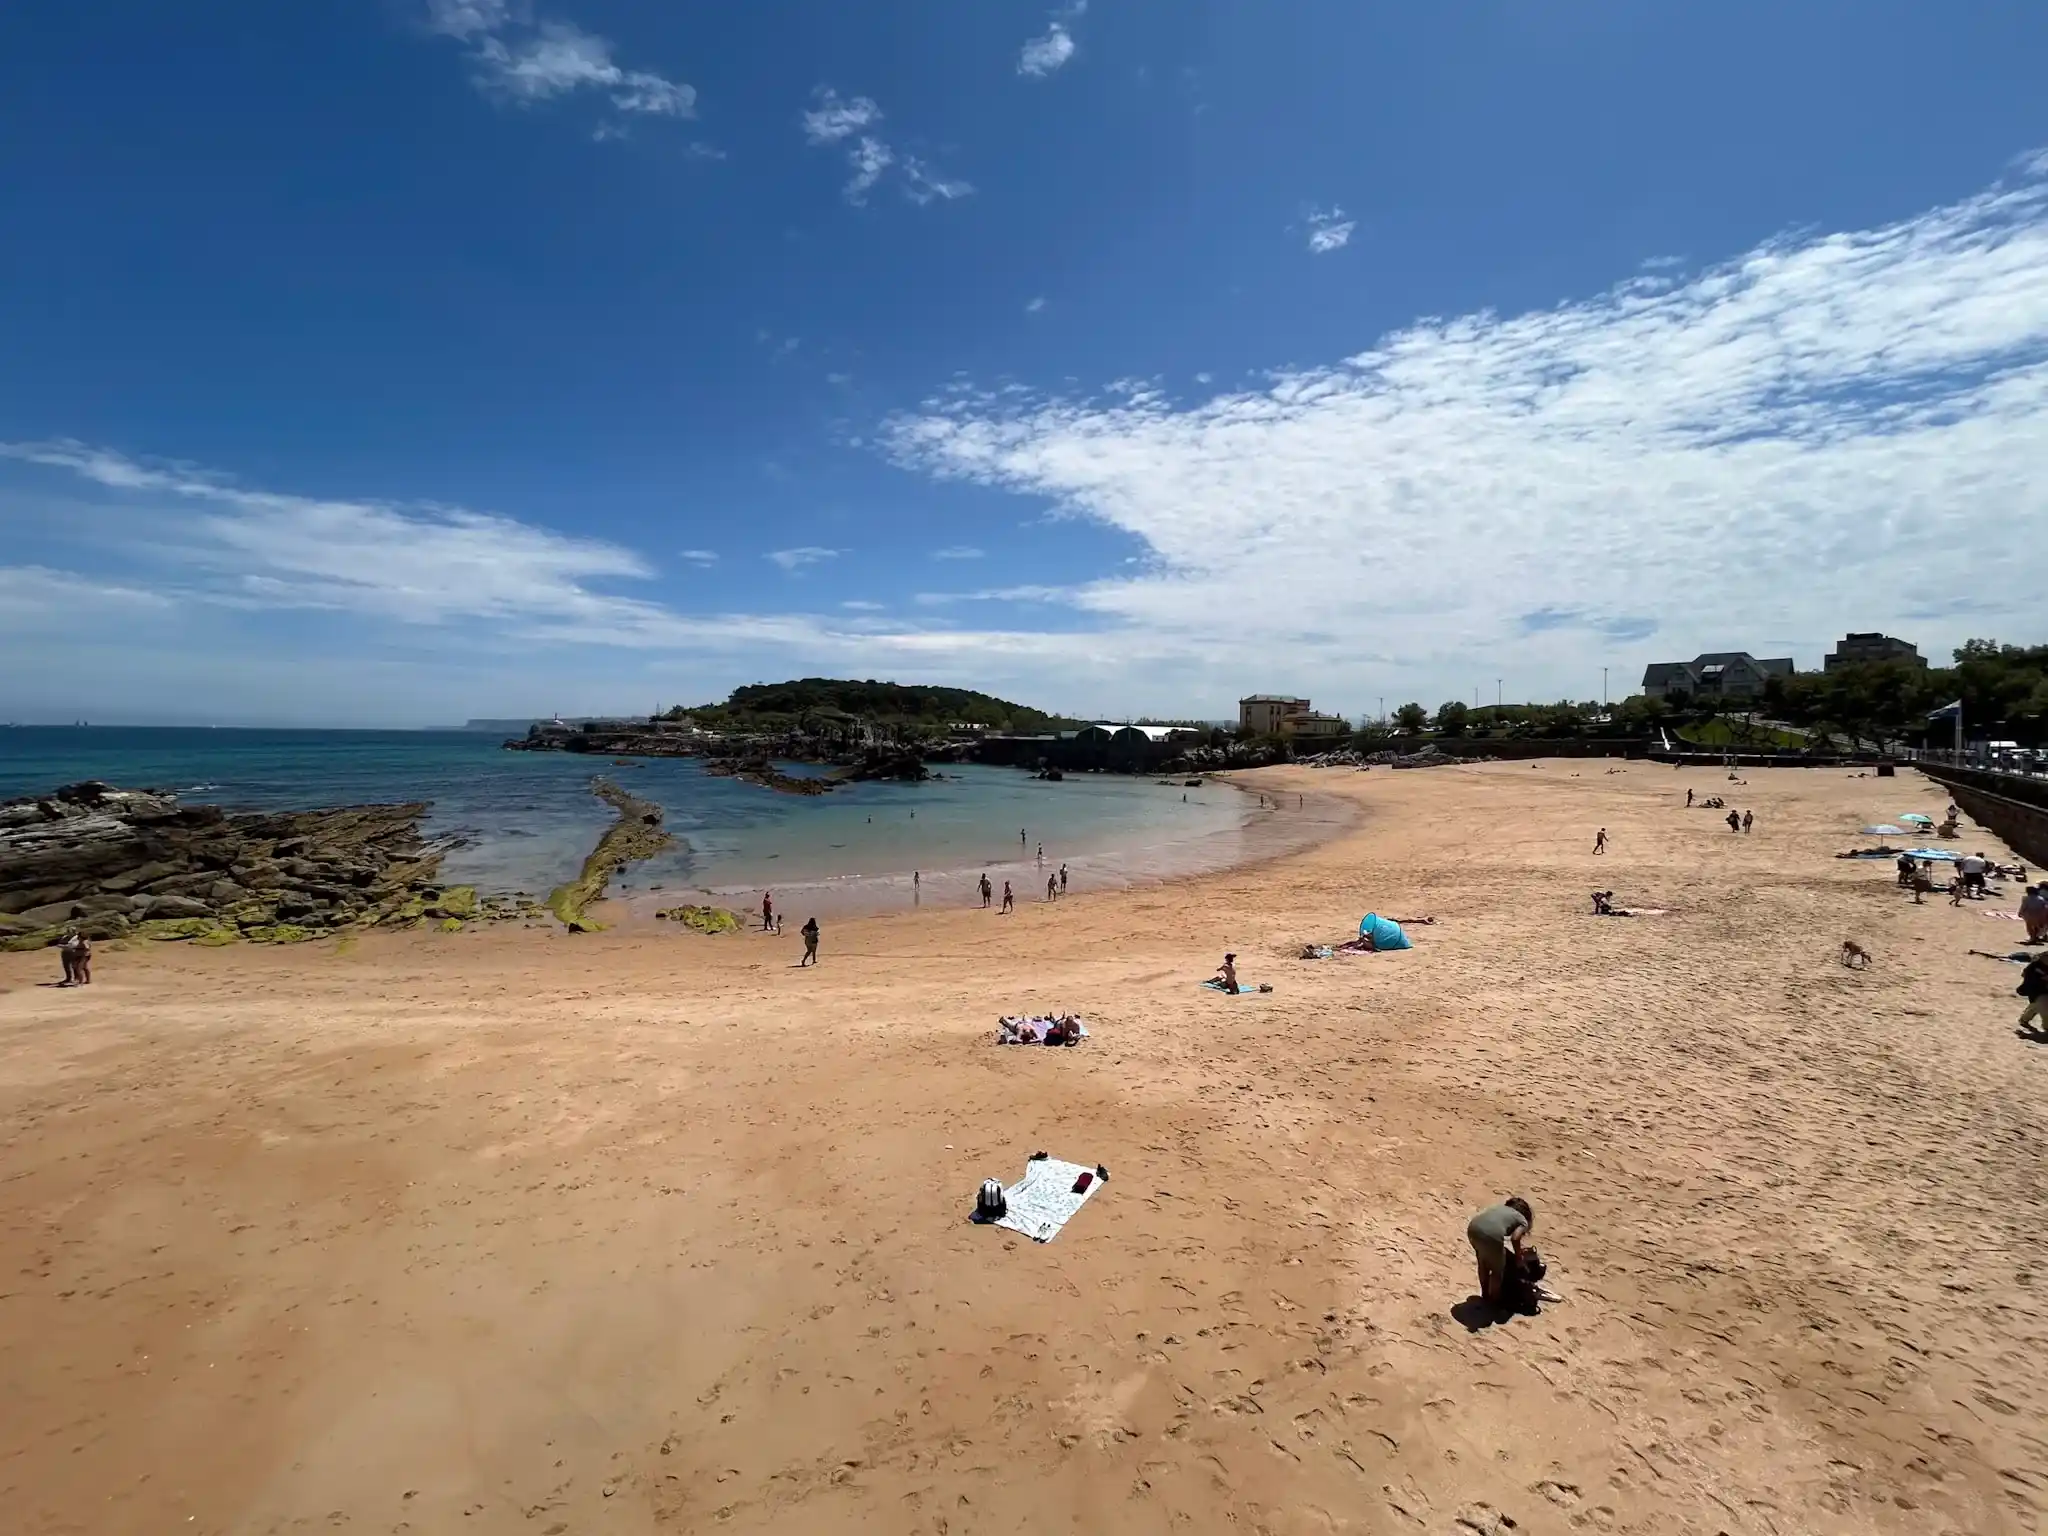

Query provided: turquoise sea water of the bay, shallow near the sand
[0,727,1321,911]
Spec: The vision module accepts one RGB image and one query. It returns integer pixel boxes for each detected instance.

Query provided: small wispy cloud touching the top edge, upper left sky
[426,0,696,123]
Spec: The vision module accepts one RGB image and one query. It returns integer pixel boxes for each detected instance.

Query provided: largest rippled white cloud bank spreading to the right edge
[887,153,2048,705]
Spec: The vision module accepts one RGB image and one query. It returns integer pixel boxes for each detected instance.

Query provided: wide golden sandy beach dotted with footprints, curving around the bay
[0,762,2048,1536]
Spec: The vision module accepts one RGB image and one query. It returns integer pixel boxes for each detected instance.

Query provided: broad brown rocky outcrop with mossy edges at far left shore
[0,782,532,948]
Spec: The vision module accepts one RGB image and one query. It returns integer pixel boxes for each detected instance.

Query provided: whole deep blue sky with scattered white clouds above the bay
[0,0,2048,725]
